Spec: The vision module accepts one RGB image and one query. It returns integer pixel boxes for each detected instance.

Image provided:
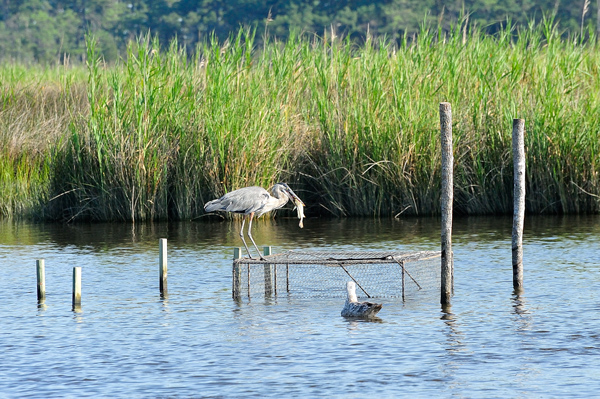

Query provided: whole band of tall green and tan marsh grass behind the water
[0,23,600,221]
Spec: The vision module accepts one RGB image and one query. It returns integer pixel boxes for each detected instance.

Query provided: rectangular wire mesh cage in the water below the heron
[233,250,440,299]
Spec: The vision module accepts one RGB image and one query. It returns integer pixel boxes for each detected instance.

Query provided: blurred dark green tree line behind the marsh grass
[0,0,600,63]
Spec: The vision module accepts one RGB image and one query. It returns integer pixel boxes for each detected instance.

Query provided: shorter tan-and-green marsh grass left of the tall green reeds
[0,65,86,218]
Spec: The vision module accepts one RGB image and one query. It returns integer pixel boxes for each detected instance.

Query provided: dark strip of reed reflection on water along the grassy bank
[0,215,600,250]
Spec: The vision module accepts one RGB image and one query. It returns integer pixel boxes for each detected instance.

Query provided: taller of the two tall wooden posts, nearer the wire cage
[440,102,454,305]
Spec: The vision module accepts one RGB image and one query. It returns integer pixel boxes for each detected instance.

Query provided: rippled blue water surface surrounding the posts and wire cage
[0,216,600,398]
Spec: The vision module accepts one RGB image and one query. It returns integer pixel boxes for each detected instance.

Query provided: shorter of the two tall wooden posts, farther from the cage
[512,119,525,290]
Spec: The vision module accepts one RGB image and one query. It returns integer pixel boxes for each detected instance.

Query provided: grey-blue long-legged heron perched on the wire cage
[204,183,304,259]
